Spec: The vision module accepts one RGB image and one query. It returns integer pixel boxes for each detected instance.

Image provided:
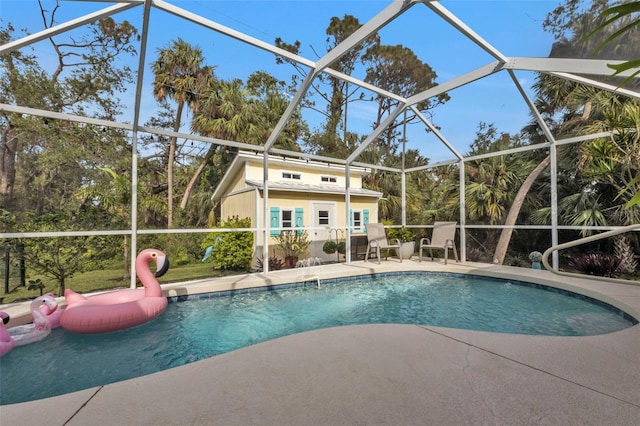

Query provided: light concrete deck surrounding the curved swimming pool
[0,259,640,426]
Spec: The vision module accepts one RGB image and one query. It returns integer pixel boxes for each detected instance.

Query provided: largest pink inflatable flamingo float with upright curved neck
[60,249,169,334]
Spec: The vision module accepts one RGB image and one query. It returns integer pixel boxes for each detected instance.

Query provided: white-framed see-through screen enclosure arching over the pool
[0,0,640,292]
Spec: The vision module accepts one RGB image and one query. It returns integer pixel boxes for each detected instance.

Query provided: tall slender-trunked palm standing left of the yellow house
[152,38,213,228]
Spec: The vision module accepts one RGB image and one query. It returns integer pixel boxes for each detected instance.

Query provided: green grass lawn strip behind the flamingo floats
[0,263,240,304]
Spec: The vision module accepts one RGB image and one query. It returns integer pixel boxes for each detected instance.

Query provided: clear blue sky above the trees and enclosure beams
[0,0,559,162]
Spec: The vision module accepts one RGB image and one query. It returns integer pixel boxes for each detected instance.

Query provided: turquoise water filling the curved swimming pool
[0,272,637,404]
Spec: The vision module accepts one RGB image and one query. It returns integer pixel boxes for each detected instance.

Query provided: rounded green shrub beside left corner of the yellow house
[200,216,253,271]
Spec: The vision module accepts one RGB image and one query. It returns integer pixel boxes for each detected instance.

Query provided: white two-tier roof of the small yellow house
[211,151,382,200]
